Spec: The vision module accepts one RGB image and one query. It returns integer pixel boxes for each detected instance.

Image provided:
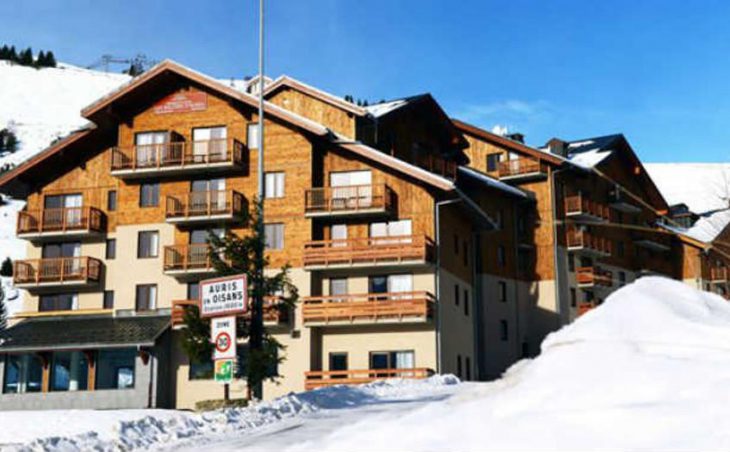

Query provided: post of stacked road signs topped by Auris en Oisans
[200,275,248,400]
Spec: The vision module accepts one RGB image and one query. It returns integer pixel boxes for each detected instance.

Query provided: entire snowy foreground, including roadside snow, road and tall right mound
[0,277,730,451]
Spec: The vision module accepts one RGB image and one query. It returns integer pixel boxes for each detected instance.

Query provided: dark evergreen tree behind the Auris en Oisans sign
[182,201,299,400]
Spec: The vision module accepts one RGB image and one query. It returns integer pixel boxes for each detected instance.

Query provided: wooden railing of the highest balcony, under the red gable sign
[112,138,245,171]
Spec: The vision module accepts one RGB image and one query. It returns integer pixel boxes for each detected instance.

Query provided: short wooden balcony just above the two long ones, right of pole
[304,184,393,217]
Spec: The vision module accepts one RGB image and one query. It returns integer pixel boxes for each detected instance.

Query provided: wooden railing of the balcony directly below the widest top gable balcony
[165,190,245,219]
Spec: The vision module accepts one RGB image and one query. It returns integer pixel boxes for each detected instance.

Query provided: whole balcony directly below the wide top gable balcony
[165,190,247,224]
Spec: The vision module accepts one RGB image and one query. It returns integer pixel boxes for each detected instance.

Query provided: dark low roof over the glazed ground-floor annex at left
[0,315,170,352]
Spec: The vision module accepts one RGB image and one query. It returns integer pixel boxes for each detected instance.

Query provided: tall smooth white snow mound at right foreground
[292,277,730,451]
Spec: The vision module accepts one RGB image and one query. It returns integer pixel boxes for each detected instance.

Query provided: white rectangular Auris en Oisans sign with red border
[200,275,248,317]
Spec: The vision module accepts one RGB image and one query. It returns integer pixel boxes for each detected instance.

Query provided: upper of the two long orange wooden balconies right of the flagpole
[304,235,433,270]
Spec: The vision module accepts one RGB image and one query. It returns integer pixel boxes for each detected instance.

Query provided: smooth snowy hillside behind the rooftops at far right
[644,163,730,214]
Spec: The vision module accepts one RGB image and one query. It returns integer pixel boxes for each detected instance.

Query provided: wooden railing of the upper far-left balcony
[17,207,104,234]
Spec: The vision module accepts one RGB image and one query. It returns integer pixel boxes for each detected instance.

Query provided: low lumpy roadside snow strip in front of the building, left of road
[0,376,458,451]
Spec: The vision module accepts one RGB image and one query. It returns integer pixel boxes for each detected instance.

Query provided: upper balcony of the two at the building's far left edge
[17,207,105,240]
